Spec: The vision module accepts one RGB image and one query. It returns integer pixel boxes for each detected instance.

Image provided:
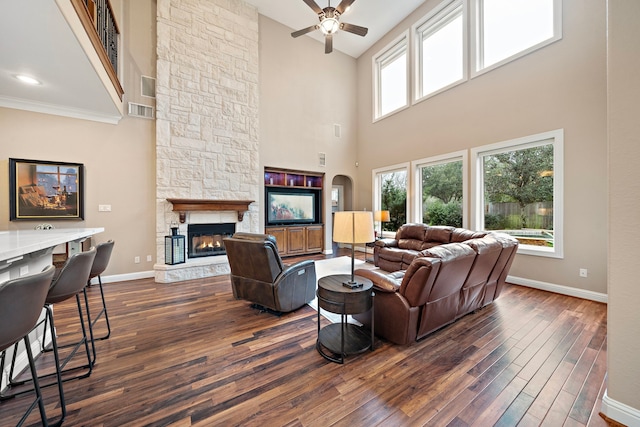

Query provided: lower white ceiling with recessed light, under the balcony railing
[0,0,120,122]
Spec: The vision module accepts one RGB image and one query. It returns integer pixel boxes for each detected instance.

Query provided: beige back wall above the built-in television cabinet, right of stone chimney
[260,15,360,250]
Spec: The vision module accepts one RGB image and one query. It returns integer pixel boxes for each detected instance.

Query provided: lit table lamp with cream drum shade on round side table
[333,211,375,288]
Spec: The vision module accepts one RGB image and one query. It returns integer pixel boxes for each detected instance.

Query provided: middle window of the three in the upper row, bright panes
[414,0,467,100]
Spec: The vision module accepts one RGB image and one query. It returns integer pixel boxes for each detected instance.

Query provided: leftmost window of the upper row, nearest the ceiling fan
[373,33,408,119]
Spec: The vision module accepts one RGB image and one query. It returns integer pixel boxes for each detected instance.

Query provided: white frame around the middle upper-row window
[411,0,469,104]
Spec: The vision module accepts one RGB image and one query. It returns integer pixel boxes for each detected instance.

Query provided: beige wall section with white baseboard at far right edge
[602,0,640,426]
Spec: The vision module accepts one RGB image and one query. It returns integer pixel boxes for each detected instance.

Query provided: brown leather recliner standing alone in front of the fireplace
[224,233,316,313]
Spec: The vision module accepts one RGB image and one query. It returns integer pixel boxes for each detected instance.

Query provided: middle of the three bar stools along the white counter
[9,248,96,398]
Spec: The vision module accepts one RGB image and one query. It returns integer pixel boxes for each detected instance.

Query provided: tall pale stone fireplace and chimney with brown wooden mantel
[154,0,261,283]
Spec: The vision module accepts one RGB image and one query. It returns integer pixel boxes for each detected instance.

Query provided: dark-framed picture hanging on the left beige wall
[9,158,84,221]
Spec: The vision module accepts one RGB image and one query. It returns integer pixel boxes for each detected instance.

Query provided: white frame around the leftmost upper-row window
[371,30,411,123]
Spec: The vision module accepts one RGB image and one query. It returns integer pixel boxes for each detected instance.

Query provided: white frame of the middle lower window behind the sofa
[410,150,469,228]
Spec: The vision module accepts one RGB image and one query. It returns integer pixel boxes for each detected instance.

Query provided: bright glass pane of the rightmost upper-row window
[475,0,562,71]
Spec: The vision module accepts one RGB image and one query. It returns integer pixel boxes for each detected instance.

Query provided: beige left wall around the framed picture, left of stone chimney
[0,0,156,276]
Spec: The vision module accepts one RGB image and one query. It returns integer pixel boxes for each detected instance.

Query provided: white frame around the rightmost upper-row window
[468,0,563,78]
